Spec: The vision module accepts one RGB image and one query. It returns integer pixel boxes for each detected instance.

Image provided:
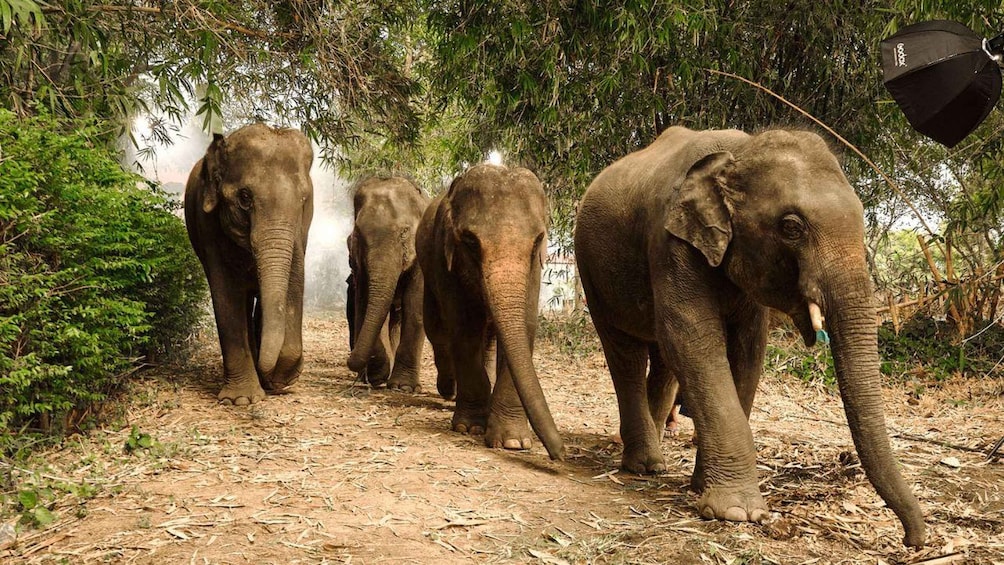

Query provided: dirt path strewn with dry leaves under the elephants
[0,319,1004,564]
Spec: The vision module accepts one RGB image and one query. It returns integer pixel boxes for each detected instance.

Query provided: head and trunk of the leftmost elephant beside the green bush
[200,123,313,389]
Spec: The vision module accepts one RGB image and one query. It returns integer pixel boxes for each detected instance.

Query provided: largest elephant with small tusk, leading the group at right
[574,126,925,547]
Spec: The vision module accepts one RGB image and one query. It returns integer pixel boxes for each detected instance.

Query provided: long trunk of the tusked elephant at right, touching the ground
[823,268,926,547]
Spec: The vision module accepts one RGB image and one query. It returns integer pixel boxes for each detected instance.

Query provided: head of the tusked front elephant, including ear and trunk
[666,130,925,546]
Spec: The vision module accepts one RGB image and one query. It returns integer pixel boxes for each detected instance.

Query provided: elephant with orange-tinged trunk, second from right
[416,164,564,460]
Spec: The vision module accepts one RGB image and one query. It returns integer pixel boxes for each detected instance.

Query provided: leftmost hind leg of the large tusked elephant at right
[593,319,666,474]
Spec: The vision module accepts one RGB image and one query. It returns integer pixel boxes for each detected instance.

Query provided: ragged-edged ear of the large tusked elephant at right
[666,152,734,267]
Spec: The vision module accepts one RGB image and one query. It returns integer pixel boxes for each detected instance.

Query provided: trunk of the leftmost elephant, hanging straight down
[251,226,295,380]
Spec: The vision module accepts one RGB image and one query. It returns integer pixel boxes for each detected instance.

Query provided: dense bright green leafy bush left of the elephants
[0,110,206,439]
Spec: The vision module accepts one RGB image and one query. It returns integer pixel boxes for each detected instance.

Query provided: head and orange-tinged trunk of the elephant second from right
[443,165,563,458]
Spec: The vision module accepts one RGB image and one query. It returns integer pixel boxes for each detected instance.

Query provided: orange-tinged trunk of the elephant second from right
[485,263,564,460]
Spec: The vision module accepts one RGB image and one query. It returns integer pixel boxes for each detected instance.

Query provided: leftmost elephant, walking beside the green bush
[185,123,313,405]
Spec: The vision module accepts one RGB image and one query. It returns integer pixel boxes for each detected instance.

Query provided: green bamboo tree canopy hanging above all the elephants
[0,0,1004,270]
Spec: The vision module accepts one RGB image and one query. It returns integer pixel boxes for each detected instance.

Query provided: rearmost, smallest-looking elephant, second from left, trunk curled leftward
[347,177,429,393]
